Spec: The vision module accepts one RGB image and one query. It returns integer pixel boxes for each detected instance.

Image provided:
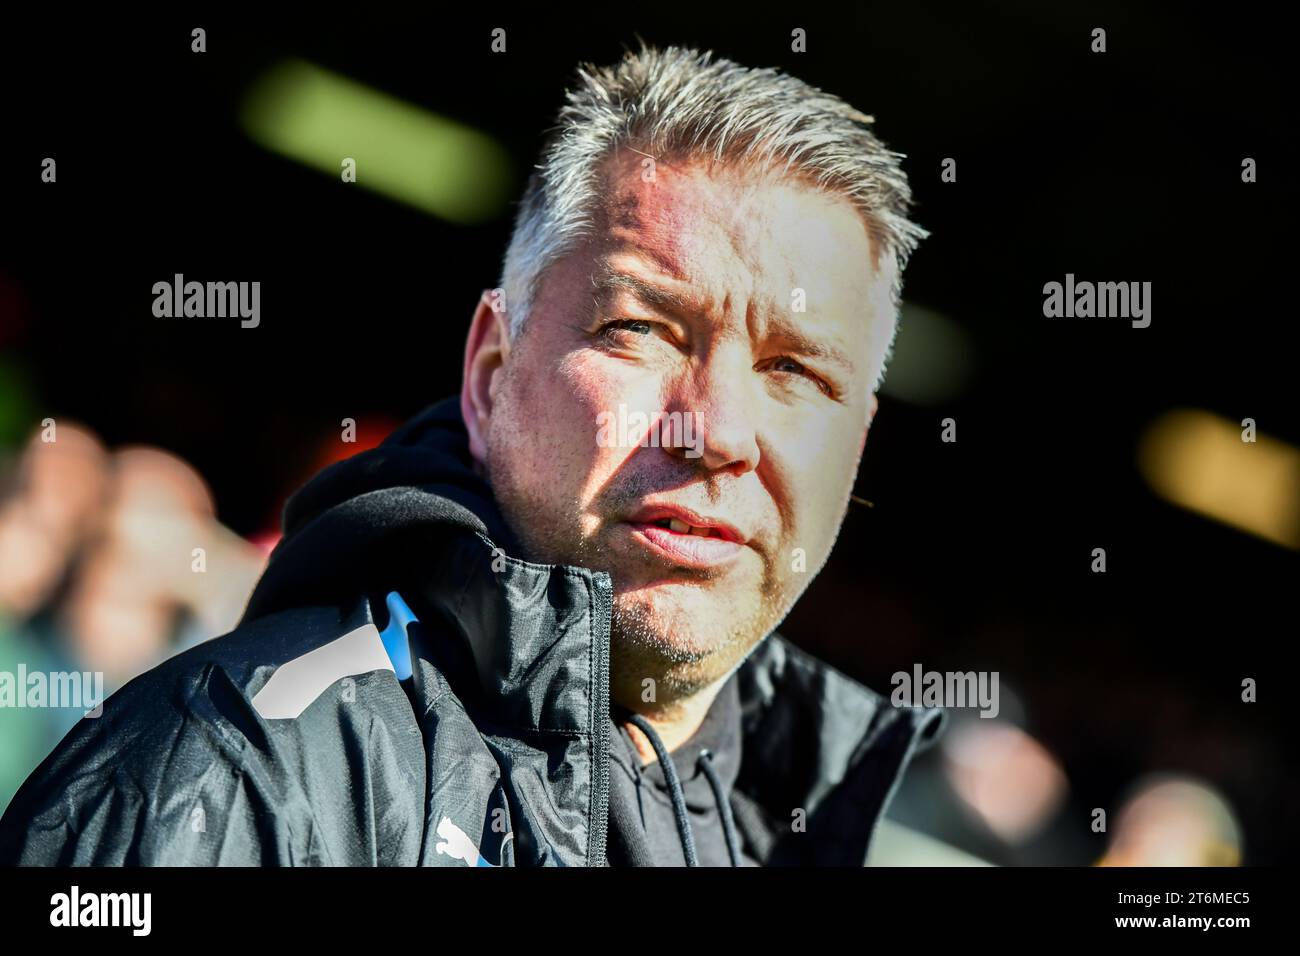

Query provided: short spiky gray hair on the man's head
[501,43,928,366]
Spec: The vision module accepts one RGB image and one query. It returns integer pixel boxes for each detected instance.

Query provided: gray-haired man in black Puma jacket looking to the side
[0,42,940,866]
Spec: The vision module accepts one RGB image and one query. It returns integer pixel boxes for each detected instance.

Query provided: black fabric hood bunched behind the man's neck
[243,397,517,622]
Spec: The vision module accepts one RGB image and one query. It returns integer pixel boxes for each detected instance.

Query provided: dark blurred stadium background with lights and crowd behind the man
[0,3,1300,864]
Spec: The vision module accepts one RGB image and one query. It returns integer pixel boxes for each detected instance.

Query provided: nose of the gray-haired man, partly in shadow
[663,343,762,475]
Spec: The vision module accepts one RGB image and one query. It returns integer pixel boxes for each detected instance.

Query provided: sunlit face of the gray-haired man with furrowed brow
[485,152,893,700]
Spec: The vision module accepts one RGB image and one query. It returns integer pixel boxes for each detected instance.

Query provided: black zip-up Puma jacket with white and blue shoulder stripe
[0,399,943,866]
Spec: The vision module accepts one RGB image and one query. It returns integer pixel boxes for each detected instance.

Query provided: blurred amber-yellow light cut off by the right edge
[1138,410,1300,549]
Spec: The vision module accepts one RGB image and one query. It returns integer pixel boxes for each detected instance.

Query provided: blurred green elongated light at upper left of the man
[239,60,511,224]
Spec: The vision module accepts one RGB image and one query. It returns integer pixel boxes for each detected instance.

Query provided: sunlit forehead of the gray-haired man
[599,150,889,316]
